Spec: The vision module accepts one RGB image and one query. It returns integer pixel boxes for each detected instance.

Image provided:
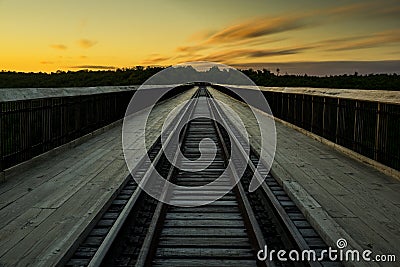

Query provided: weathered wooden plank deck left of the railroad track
[0,90,194,266]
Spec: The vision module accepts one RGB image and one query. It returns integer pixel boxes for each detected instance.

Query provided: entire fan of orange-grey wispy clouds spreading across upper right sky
[139,2,400,64]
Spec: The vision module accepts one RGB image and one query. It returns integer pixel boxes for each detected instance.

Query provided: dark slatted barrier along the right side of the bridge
[214,86,400,170]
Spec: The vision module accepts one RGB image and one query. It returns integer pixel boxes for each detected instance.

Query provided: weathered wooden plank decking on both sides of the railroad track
[0,87,400,266]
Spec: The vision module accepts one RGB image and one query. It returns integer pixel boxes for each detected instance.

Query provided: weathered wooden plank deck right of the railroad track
[211,87,400,266]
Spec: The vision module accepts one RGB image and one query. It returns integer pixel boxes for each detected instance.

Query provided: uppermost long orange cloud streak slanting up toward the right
[170,3,372,58]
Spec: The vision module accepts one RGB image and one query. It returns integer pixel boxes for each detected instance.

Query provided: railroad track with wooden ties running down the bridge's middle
[62,86,340,266]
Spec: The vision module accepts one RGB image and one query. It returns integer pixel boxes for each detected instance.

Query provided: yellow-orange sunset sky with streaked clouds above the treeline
[0,0,400,72]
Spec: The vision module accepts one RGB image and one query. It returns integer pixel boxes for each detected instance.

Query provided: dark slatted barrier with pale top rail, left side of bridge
[0,86,192,174]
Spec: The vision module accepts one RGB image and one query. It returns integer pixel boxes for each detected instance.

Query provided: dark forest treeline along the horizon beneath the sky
[0,66,400,90]
